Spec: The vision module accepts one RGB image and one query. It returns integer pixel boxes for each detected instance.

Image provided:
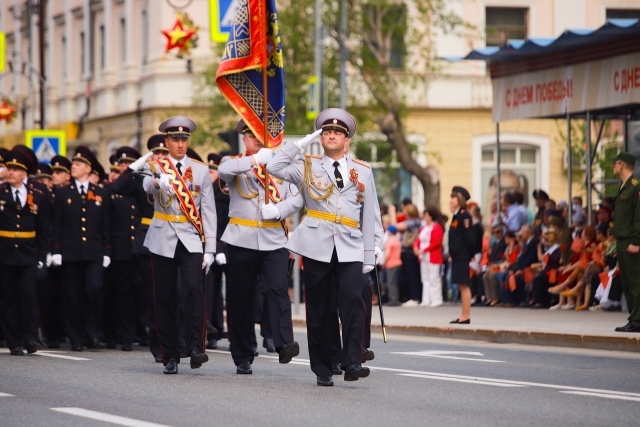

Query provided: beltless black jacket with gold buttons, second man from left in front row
[53,181,111,263]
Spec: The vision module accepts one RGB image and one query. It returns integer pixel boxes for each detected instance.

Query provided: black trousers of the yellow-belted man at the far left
[0,263,37,348]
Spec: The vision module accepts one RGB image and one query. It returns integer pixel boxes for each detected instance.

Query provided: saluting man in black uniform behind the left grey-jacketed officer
[110,134,169,363]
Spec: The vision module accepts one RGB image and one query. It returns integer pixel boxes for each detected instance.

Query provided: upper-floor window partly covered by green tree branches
[362,5,407,70]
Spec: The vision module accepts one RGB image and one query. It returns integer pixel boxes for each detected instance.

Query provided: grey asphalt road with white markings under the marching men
[0,329,640,427]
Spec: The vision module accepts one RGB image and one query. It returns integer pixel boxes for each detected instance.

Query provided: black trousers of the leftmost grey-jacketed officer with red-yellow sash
[151,240,206,364]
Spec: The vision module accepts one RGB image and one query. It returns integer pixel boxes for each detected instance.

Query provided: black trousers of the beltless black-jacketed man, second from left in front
[62,260,104,345]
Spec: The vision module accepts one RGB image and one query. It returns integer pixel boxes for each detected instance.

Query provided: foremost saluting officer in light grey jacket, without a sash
[268,108,382,386]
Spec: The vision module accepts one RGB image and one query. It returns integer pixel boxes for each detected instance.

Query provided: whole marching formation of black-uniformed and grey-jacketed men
[0,108,383,386]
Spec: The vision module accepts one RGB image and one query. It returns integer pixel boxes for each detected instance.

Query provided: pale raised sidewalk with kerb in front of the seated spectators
[292,303,640,352]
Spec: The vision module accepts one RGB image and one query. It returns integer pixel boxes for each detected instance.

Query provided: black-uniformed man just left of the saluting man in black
[104,146,142,351]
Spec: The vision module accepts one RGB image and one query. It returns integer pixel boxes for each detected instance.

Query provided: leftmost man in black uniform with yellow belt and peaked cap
[0,150,51,356]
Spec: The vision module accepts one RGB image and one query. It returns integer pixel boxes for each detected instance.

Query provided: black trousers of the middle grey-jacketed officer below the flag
[227,245,293,366]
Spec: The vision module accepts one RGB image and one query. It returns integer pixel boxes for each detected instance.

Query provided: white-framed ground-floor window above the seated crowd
[480,144,539,221]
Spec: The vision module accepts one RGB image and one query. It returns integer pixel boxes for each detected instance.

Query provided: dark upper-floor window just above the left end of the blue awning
[486,7,529,46]
